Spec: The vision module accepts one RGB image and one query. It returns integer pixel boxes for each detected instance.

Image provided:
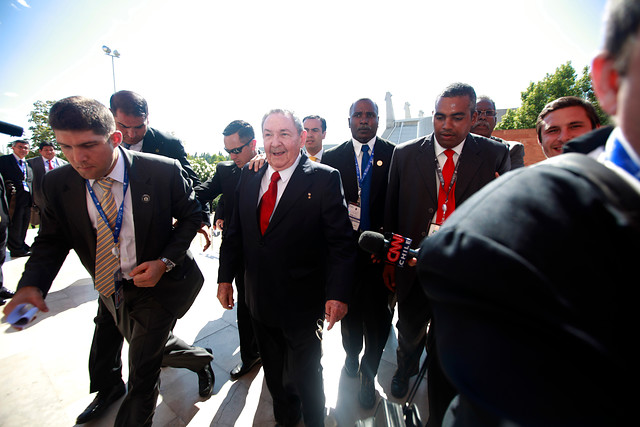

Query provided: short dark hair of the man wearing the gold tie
[49,96,116,137]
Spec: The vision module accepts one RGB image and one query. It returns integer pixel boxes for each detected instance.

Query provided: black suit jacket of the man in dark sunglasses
[195,161,241,225]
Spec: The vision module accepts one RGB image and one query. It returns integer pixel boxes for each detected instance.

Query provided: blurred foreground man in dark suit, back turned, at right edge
[419,0,640,427]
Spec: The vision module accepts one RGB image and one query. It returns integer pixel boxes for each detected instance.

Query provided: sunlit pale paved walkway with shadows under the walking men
[0,230,428,427]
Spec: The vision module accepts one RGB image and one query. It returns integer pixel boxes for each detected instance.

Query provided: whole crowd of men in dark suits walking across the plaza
[0,0,640,426]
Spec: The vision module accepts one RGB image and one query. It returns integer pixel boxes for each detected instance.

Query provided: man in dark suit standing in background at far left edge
[0,139,33,258]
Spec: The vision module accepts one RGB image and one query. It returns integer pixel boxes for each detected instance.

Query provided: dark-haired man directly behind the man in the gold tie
[109,90,200,187]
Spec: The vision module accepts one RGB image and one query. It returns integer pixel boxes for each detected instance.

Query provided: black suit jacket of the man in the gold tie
[18,150,203,317]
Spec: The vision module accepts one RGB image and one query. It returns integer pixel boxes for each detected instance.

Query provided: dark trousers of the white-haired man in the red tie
[252,313,325,427]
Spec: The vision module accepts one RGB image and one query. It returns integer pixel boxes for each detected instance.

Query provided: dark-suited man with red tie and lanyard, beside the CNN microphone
[385,83,510,424]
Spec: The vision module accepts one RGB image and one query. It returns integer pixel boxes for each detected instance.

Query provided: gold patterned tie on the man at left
[94,177,120,297]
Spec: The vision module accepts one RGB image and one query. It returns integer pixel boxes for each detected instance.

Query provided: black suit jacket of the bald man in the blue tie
[322,137,395,236]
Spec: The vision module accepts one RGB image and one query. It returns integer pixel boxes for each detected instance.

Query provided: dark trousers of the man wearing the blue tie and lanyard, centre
[340,251,393,378]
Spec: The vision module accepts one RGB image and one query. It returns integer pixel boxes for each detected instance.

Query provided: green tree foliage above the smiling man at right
[496,61,609,129]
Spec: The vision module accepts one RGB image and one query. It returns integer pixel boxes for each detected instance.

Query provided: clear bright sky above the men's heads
[0,0,605,154]
